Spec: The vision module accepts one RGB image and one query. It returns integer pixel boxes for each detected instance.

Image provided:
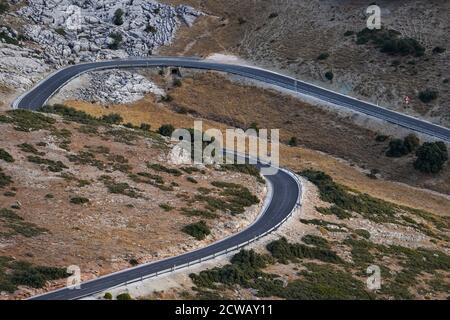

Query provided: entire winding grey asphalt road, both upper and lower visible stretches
[13,57,450,300]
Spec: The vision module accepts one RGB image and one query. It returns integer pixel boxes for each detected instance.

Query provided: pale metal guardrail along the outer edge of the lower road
[77,168,303,299]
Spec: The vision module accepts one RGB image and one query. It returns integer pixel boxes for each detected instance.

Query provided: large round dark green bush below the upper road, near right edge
[414,141,448,173]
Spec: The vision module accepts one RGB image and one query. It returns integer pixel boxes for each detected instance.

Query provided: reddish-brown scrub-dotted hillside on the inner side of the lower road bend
[0,106,265,300]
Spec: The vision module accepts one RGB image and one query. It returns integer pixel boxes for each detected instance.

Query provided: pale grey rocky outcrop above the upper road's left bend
[0,0,201,101]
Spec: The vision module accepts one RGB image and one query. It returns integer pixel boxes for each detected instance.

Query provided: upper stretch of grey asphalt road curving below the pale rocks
[13,57,450,142]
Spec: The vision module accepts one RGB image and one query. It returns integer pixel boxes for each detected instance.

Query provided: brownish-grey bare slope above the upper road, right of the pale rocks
[160,0,450,126]
